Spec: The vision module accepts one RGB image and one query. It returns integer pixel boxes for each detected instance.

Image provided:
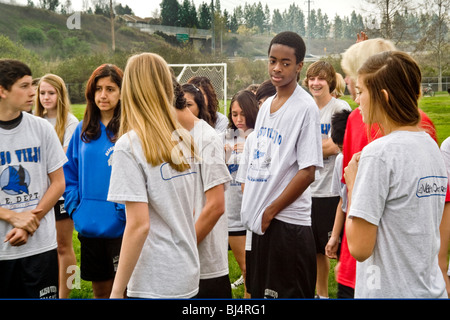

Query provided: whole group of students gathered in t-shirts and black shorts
[0,32,450,299]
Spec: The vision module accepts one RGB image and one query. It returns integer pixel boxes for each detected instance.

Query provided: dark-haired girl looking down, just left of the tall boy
[224,90,259,296]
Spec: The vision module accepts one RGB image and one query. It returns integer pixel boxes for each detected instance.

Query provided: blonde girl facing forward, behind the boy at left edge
[34,74,79,299]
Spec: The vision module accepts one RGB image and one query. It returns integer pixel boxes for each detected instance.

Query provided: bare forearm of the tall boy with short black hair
[261,166,316,232]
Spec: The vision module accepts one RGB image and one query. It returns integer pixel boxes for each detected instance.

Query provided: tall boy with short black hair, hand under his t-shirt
[238,32,323,298]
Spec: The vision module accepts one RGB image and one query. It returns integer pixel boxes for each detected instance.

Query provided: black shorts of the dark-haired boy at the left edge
[0,249,58,299]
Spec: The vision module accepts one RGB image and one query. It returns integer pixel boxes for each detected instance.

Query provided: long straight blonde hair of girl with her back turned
[119,53,194,172]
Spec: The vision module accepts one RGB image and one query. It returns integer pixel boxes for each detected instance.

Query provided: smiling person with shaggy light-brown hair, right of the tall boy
[303,61,352,298]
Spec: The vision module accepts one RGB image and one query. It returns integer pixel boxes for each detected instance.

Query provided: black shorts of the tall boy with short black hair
[247,219,317,299]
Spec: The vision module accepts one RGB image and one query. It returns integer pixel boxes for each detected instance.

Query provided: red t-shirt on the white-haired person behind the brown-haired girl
[336,108,438,288]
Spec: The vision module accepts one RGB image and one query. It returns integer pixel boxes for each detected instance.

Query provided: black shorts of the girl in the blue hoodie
[78,234,122,281]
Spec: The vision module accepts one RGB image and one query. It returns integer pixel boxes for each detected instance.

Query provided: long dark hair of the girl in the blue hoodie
[81,64,123,143]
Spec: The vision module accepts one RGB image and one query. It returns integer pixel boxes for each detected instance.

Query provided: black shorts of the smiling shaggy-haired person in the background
[311,197,340,254]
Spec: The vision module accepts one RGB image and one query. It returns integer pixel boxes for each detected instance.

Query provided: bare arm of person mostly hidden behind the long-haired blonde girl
[195,184,225,244]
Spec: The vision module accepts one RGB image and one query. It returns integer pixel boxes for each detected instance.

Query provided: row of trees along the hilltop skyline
[159,0,448,41]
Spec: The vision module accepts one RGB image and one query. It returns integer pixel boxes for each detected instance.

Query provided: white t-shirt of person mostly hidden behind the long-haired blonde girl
[190,120,231,279]
